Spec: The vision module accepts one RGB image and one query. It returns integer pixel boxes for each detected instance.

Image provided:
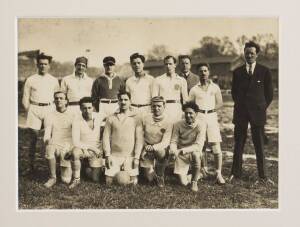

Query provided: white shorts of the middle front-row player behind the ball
[105,155,139,177]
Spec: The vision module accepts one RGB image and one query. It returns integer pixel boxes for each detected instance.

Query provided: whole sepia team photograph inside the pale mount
[16,17,279,210]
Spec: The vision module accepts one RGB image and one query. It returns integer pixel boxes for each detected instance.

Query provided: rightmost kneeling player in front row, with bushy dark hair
[170,102,206,191]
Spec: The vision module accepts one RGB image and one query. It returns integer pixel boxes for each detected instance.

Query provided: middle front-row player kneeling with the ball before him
[103,91,143,185]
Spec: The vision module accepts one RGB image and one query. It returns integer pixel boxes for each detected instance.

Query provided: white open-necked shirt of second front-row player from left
[72,113,103,149]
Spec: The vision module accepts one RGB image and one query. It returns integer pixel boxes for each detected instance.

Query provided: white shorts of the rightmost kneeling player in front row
[174,152,201,175]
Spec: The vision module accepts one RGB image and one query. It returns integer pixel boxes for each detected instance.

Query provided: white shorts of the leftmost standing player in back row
[26,104,54,130]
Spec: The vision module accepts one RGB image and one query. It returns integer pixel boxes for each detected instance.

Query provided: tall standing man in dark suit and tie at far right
[229,41,274,185]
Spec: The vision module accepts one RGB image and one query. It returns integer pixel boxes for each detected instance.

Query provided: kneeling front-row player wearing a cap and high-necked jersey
[140,96,173,187]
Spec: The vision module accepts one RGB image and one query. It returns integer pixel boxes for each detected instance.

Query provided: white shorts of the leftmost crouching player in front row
[45,143,72,167]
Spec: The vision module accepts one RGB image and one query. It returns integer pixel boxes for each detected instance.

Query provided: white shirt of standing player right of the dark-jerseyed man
[126,74,154,104]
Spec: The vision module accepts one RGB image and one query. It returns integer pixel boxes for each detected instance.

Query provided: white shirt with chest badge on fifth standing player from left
[153,73,188,102]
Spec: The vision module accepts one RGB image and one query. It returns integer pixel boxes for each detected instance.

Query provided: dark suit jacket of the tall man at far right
[231,63,273,125]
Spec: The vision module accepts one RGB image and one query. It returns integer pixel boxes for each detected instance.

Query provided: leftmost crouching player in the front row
[44,91,74,188]
